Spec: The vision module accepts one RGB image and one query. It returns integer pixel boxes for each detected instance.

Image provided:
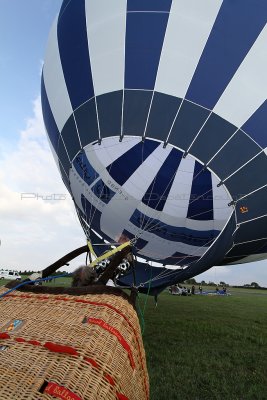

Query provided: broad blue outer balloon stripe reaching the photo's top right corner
[186,0,267,109]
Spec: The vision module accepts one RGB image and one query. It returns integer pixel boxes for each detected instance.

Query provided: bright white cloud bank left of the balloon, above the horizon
[0,97,85,269]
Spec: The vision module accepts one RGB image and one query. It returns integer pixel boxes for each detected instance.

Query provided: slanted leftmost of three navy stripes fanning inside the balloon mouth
[107,140,159,185]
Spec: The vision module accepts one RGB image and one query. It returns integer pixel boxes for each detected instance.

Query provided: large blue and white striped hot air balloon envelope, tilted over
[42,0,267,293]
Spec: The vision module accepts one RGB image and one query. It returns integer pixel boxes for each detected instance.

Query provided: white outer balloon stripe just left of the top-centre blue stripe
[85,0,127,96]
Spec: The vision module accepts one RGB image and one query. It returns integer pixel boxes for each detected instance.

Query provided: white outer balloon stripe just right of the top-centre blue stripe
[155,0,222,98]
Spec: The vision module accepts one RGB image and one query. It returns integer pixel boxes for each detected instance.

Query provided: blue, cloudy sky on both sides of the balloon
[0,0,267,287]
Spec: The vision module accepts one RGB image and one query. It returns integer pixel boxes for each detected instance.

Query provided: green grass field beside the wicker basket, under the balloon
[0,278,267,400]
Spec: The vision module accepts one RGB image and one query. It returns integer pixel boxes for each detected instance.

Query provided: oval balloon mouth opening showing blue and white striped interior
[69,136,233,267]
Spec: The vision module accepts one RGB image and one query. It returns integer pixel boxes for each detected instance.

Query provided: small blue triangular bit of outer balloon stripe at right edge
[242,100,267,147]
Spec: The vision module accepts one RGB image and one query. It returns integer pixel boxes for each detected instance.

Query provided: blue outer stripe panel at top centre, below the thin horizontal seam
[125,13,169,89]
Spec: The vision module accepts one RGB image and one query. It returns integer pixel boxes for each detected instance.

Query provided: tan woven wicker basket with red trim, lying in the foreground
[0,288,149,400]
